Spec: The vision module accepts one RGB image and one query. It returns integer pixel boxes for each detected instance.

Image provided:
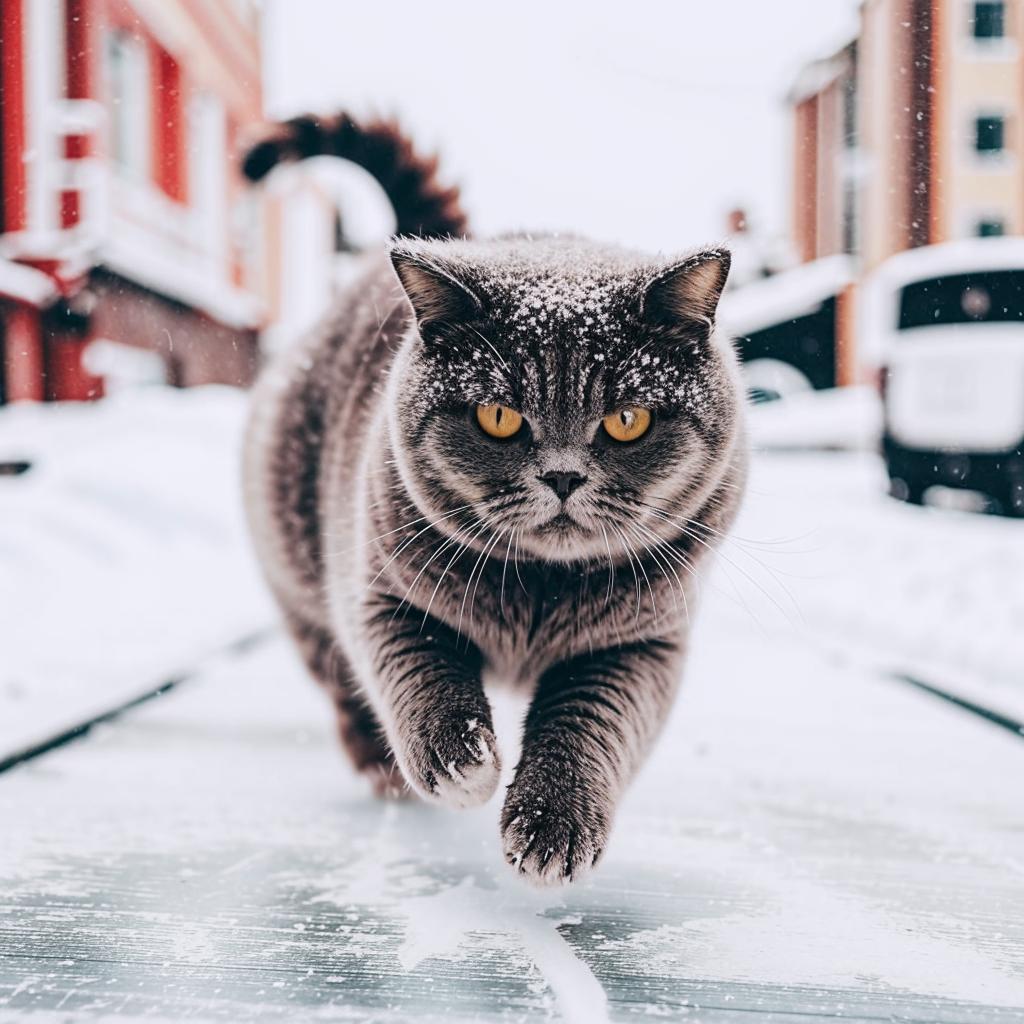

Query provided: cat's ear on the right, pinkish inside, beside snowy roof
[641,249,732,337]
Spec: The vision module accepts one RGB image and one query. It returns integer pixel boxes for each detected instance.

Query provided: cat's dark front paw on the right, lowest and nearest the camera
[502,779,610,886]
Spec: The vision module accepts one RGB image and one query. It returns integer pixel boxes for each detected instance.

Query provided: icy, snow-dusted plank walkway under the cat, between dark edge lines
[0,601,1024,1022]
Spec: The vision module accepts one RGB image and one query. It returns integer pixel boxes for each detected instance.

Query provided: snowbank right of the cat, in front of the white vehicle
[715,452,1024,717]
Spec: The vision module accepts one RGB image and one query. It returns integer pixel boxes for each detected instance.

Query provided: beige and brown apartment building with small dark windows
[790,0,1024,271]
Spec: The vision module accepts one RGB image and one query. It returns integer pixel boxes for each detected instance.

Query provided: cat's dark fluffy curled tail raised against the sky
[242,114,466,238]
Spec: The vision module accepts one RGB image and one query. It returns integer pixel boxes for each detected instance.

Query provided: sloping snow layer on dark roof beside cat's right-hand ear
[718,256,855,337]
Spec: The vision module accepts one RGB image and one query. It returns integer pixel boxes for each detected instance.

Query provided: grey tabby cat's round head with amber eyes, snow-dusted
[389,239,740,562]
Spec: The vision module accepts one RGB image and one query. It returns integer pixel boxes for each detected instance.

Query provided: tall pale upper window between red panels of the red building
[106,31,152,181]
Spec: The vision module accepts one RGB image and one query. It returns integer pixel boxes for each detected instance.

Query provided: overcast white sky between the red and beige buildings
[264,0,857,251]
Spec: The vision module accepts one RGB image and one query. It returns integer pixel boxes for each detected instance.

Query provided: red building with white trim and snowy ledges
[0,0,267,401]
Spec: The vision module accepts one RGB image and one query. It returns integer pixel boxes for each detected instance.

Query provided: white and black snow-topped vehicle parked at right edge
[858,238,1024,516]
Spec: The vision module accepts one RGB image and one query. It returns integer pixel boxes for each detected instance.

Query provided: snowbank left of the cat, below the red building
[0,387,271,754]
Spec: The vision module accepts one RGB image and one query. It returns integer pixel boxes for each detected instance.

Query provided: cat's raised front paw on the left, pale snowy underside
[406,718,501,807]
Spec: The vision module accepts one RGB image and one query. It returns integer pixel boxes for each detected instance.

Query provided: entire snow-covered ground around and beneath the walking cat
[0,389,1024,1024]
